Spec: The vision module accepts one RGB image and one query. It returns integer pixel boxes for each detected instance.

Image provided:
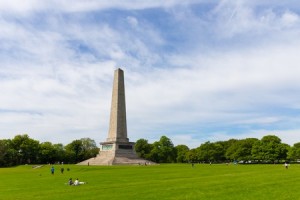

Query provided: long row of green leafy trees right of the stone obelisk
[135,135,300,163]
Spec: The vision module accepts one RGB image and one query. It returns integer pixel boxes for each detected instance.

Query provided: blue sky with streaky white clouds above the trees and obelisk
[0,0,300,148]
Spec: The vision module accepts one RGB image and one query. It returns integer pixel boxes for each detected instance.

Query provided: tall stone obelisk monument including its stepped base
[78,69,154,165]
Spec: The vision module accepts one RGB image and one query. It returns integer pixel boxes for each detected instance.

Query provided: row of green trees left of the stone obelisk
[0,134,99,167]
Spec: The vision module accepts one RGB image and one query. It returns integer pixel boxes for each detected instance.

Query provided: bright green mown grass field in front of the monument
[0,164,300,200]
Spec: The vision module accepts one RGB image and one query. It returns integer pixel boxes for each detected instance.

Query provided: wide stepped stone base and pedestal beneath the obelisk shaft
[77,142,156,165]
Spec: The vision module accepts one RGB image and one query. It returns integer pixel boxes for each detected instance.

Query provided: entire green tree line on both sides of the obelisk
[0,134,300,167]
